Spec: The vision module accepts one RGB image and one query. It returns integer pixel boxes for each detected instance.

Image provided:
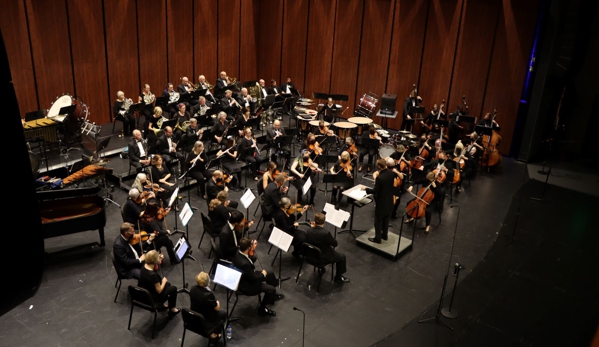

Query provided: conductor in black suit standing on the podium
[362,159,395,243]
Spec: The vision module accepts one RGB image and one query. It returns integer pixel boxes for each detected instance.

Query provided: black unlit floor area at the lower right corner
[376,180,599,347]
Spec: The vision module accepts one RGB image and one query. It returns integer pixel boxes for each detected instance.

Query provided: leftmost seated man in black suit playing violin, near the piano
[112,222,154,280]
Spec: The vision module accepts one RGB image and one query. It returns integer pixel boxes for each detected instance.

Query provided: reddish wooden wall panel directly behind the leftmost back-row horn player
[104,0,141,107]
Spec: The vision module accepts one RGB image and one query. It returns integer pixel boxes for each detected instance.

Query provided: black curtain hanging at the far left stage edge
[0,31,44,316]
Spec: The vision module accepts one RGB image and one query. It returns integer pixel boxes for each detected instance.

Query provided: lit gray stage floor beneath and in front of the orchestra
[0,148,526,346]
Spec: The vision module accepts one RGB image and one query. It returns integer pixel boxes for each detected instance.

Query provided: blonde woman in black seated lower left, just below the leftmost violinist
[137,250,181,317]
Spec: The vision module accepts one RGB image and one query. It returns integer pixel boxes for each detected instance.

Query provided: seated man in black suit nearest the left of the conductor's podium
[305,213,349,282]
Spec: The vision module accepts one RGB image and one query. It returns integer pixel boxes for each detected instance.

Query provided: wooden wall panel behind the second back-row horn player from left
[137,0,166,96]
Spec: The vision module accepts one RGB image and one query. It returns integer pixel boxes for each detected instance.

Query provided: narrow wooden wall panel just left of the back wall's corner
[239,0,261,81]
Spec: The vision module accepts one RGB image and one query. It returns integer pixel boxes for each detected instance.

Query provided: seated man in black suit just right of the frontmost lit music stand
[233,237,285,316]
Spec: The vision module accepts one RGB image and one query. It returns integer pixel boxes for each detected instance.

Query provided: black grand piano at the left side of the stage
[37,187,106,246]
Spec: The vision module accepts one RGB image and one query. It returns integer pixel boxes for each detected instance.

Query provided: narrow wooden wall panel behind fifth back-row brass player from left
[193,0,219,84]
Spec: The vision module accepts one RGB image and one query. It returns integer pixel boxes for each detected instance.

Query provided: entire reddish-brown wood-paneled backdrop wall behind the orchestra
[0,0,539,153]
